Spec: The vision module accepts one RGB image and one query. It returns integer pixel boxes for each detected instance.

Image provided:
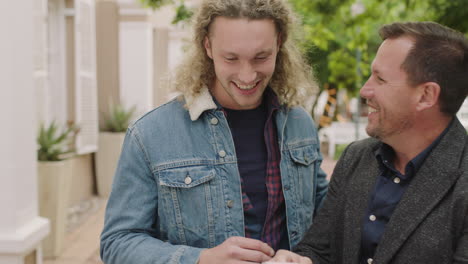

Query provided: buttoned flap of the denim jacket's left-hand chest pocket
[159,166,215,188]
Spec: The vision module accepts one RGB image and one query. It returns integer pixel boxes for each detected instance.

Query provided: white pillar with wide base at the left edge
[0,0,49,263]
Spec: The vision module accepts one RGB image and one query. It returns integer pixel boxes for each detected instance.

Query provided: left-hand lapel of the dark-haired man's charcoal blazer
[343,147,380,263]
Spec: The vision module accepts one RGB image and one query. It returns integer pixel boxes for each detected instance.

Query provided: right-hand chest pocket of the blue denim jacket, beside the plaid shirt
[289,144,319,206]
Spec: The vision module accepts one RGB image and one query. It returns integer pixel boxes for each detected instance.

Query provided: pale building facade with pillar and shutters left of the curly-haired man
[0,0,191,264]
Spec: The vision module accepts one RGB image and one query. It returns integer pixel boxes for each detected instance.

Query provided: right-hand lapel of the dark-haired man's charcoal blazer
[374,120,466,263]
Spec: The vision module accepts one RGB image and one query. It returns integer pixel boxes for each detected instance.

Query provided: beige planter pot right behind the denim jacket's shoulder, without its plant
[95,132,125,197]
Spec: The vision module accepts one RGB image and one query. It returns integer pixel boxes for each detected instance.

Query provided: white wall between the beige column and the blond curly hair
[118,0,194,111]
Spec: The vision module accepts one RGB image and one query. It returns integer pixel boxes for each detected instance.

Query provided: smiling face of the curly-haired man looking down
[205,17,279,110]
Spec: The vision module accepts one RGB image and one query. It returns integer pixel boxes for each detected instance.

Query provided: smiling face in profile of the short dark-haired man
[360,37,418,143]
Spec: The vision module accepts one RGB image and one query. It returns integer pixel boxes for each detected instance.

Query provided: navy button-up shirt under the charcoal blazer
[359,121,453,264]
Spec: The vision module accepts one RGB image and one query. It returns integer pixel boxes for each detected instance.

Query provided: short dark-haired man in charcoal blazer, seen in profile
[273,22,468,264]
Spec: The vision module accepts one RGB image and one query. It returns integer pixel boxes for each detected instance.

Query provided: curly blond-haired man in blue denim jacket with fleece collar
[101,0,328,264]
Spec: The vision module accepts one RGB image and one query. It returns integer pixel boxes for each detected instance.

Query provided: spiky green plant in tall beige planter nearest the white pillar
[37,122,79,257]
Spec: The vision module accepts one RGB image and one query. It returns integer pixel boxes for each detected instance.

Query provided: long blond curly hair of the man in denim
[173,0,318,107]
